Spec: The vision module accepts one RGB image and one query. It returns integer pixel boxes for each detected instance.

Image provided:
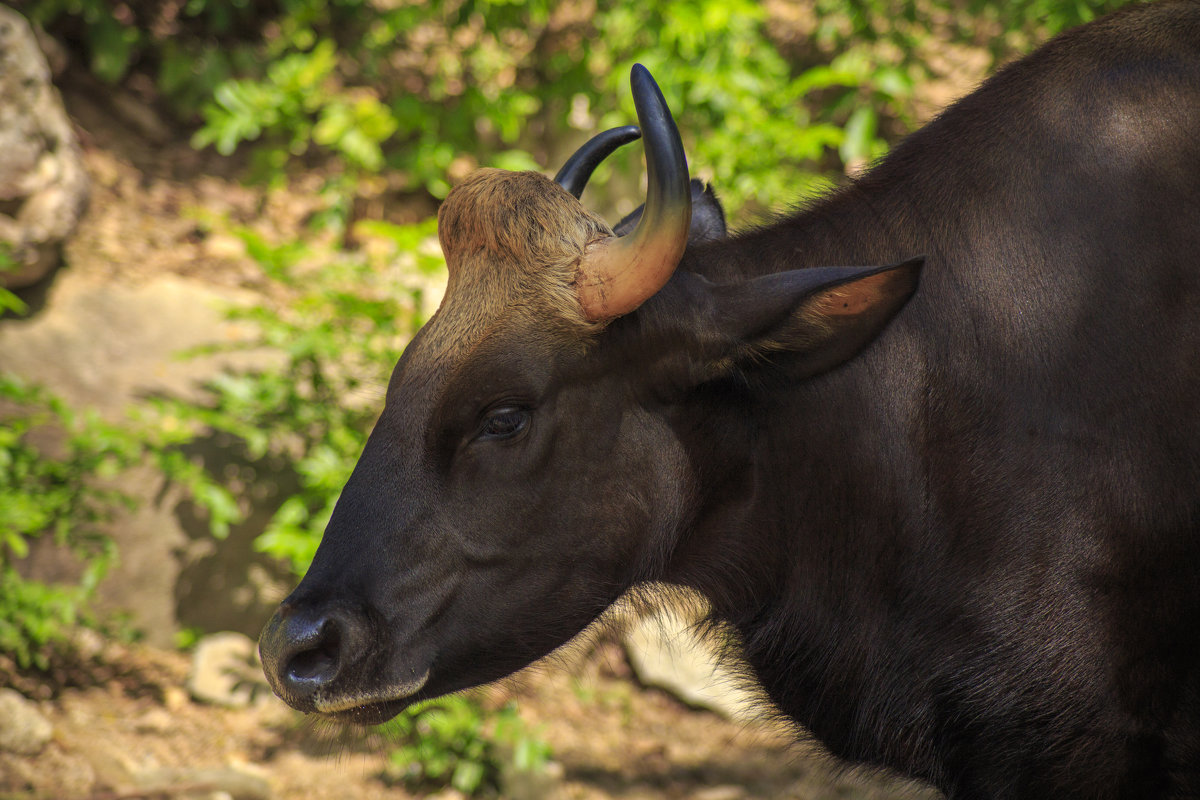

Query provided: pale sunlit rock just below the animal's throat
[625,609,763,720]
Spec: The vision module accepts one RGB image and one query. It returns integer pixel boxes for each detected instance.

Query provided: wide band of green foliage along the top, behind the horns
[30,0,1123,219]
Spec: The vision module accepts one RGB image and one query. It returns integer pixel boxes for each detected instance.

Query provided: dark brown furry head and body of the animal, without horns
[262,0,1200,800]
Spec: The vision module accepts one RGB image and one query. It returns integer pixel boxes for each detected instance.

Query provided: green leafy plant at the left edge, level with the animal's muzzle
[0,373,142,669]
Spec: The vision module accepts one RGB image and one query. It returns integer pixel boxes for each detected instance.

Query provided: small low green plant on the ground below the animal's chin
[382,696,550,795]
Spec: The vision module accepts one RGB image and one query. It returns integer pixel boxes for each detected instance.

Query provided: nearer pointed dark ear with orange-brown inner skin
[712,257,925,378]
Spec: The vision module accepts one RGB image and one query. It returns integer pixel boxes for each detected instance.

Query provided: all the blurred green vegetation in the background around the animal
[0,0,1121,793]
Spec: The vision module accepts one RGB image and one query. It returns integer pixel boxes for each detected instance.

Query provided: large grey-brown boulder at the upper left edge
[0,6,89,288]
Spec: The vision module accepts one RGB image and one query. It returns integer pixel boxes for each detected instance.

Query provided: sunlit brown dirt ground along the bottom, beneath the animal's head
[0,642,934,800]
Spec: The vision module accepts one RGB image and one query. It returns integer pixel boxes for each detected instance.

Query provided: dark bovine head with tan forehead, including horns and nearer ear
[260,66,916,723]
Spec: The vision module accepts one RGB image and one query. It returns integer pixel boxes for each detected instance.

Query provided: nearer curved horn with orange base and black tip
[576,64,691,321]
